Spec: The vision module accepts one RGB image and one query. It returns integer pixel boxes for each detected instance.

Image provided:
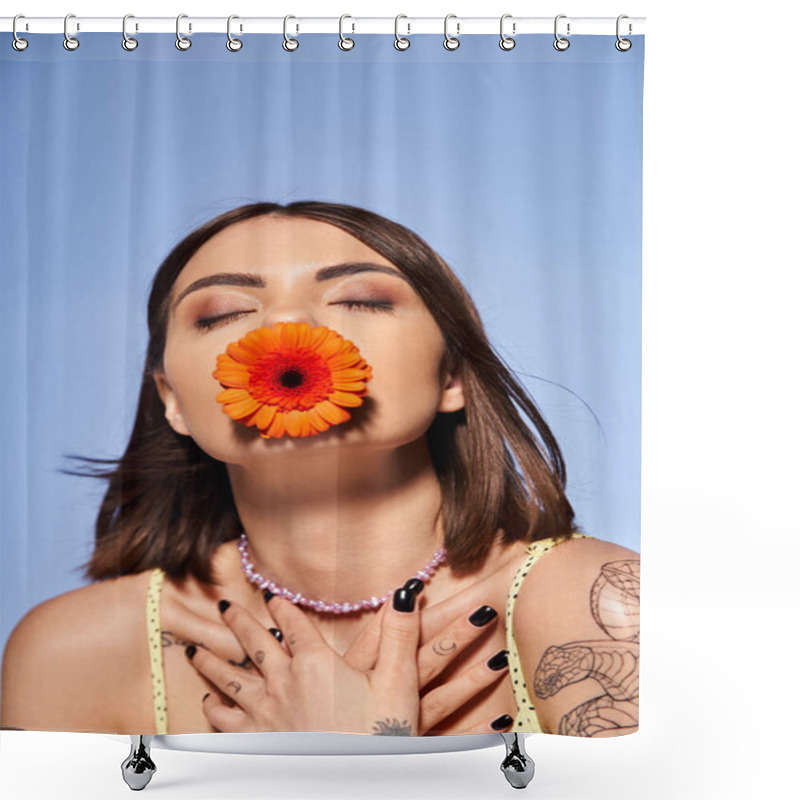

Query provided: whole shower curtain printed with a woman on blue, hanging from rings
[0,24,644,737]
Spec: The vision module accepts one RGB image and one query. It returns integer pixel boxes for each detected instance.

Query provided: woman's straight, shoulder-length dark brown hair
[65,200,579,585]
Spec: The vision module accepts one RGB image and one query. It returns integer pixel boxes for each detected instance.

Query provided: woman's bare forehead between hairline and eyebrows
[174,217,393,284]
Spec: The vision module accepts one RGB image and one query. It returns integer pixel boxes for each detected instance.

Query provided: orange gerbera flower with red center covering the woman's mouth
[212,322,372,439]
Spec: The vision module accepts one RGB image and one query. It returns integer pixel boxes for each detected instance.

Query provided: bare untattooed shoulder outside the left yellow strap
[0,571,150,733]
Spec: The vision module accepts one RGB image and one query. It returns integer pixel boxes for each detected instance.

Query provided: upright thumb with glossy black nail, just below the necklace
[374,588,419,697]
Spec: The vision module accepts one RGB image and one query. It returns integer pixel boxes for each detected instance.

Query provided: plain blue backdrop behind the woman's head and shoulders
[0,33,644,643]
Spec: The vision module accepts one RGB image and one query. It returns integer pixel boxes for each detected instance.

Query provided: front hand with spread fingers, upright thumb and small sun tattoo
[187,589,419,736]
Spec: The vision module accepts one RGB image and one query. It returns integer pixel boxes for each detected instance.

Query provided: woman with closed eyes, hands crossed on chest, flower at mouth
[2,201,638,736]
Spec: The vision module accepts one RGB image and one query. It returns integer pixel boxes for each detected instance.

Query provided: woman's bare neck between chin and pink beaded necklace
[228,439,444,603]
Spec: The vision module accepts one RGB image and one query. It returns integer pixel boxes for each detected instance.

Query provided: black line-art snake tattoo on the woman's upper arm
[533,559,639,737]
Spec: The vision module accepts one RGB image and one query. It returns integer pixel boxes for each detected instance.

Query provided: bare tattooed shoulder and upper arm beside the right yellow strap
[514,539,639,737]
